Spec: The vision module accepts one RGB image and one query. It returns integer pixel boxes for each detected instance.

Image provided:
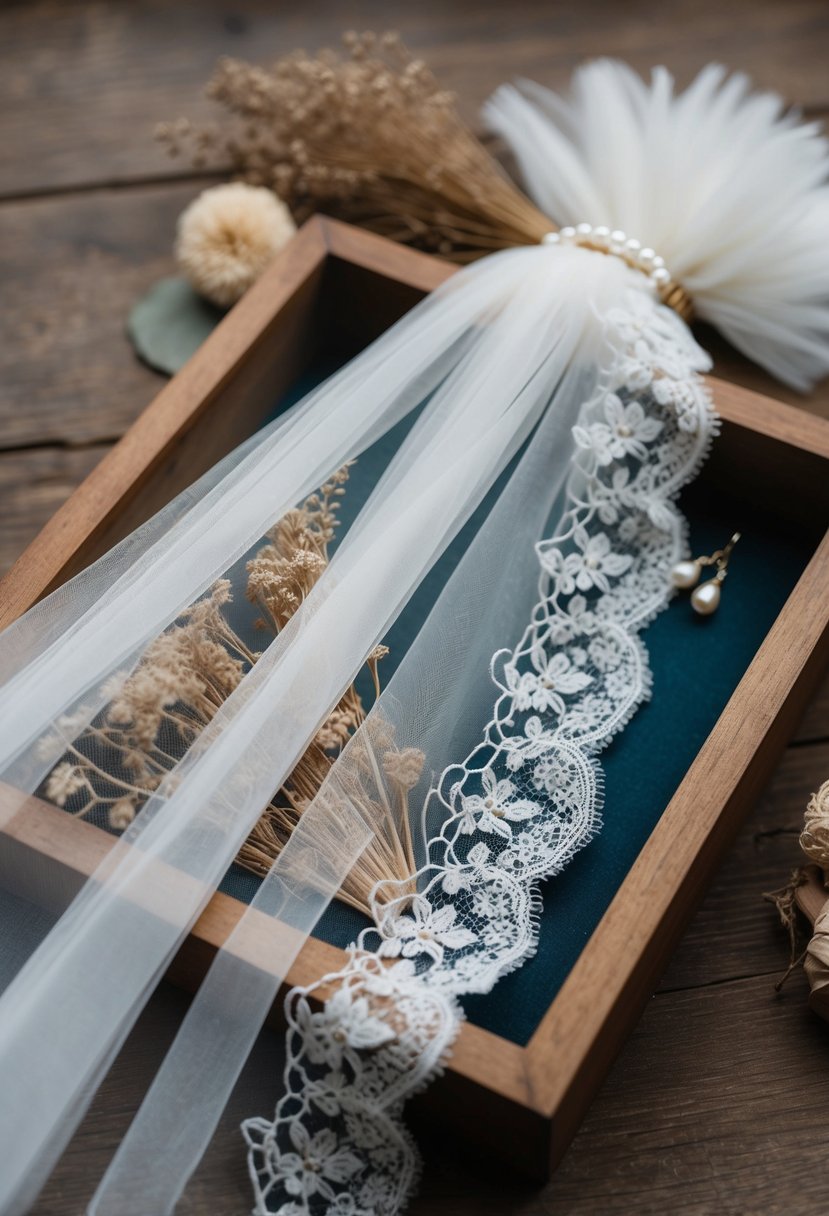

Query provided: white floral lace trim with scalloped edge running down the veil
[243,288,716,1216]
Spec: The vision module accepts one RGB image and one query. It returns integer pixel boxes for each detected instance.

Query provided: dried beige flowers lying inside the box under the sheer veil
[40,466,423,911]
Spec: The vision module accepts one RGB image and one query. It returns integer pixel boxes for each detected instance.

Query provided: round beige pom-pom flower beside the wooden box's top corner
[175,181,297,308]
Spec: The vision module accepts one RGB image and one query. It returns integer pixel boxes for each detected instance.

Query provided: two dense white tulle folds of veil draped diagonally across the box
[0,241,632,1211]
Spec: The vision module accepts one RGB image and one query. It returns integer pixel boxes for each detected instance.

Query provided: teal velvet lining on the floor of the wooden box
[215,359,816,1045]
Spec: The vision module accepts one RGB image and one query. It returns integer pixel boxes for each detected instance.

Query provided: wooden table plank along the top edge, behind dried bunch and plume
[0,0,829,195]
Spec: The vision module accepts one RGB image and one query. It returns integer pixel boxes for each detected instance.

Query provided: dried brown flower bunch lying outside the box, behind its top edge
[158,33,553,261]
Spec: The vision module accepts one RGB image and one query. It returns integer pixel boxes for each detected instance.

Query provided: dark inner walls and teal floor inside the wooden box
[12,257,828,1046]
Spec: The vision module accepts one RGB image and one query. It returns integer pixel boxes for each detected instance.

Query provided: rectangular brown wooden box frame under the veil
[0,218,829,1177]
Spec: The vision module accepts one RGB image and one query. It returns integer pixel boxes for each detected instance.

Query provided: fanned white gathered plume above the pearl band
[485,60,829,389]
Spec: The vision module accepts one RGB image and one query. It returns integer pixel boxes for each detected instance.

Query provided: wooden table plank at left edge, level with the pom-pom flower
[0,185,188,449]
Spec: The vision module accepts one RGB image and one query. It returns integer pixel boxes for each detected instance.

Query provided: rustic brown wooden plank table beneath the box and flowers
[0,0,829,1216]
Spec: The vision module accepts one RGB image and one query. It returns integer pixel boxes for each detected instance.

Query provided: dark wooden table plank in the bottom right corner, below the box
[413,976,829,1216]
